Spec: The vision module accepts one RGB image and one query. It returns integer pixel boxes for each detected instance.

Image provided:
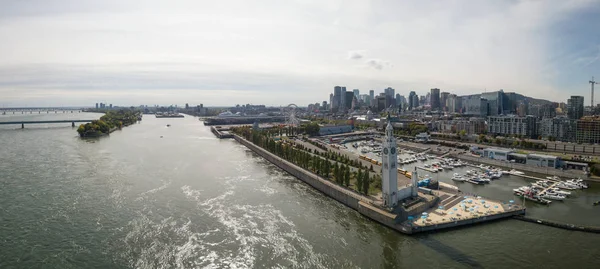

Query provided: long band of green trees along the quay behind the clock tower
[232,127,374,194]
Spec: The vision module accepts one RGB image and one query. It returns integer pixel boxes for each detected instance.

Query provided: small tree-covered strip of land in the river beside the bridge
[77,109,142,137]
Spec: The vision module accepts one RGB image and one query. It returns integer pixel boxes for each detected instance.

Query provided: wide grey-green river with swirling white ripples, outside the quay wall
[0,113,600,268]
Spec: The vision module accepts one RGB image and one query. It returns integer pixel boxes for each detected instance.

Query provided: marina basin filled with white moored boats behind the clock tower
[310,132,600,226]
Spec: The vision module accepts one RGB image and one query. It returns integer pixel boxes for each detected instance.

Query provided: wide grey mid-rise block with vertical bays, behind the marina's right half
[487,115,537,138]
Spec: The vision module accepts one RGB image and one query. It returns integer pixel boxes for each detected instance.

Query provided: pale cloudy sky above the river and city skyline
[0,0,600,107]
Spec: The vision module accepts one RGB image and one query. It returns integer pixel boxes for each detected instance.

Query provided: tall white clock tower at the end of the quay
[381,115,398,207]
